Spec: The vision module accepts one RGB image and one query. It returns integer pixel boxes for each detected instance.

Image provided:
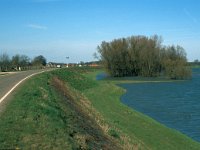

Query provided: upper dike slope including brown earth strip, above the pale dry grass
[0,69,117,149]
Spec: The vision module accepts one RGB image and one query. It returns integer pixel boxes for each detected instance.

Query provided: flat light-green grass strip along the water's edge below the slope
[84,69,200,150]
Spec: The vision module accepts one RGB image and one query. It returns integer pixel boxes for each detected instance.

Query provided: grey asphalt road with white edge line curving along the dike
[0,70,47,104]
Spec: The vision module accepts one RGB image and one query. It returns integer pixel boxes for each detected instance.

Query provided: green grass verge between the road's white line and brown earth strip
[0,74,77,149]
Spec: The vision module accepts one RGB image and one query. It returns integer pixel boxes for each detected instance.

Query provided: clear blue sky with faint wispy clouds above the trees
[0,0,200,63]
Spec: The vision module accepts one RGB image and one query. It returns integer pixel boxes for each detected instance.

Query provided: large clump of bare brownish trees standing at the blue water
[97,35,191,79]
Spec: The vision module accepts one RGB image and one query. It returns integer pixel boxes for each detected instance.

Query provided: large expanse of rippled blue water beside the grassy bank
[120,69,200,141]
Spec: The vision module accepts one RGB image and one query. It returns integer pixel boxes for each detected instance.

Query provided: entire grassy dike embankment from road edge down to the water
[0,68,200,150]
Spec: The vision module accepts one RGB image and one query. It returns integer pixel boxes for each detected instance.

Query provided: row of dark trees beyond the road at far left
[0,53,46,71]
